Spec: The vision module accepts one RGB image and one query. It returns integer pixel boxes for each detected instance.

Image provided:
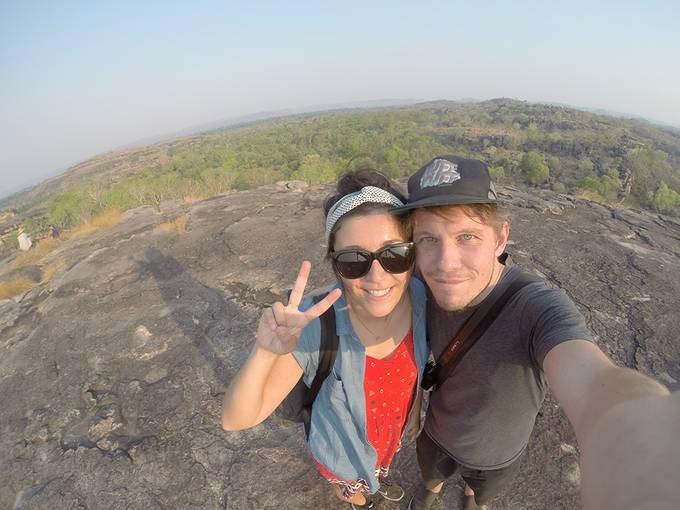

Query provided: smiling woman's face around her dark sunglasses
[333,213,412,317]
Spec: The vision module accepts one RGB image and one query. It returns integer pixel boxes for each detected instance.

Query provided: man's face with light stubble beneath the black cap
[413,207,509,312]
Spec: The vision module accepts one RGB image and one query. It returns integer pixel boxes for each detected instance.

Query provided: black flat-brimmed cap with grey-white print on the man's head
[392,156,498,213]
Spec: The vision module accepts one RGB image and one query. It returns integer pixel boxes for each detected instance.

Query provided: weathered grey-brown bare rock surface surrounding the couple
[0,182,680,510]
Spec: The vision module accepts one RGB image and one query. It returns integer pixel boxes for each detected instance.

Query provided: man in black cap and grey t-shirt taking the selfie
[397,156,680,510]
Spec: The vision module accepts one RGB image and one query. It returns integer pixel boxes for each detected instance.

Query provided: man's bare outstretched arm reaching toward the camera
[543,340,680,510]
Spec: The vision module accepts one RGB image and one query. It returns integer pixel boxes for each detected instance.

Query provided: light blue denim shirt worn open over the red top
[292,278,430,494]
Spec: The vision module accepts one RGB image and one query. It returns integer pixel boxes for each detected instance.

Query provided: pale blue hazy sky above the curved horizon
[0,0,680,196]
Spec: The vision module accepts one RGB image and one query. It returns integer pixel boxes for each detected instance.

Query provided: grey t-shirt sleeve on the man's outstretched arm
[521,282,593,369]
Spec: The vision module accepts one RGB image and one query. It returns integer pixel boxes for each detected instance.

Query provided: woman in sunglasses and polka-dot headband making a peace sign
[223,170,428,508]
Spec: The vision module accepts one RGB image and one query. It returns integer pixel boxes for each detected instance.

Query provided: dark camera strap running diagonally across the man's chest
[436,272,541,386]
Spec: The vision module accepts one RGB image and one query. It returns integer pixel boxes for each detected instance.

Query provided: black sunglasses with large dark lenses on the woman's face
[331,243,416,280]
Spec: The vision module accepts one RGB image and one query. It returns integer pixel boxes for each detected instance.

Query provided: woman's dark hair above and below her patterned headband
[323,168,411,258]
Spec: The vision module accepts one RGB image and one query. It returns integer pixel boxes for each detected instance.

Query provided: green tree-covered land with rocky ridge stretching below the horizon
[7,99,680,237]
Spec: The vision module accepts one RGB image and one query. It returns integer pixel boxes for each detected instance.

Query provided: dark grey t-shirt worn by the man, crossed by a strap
[425,262,592,470]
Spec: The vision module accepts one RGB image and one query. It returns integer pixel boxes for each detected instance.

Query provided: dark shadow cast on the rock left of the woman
[142,248,240,386]
